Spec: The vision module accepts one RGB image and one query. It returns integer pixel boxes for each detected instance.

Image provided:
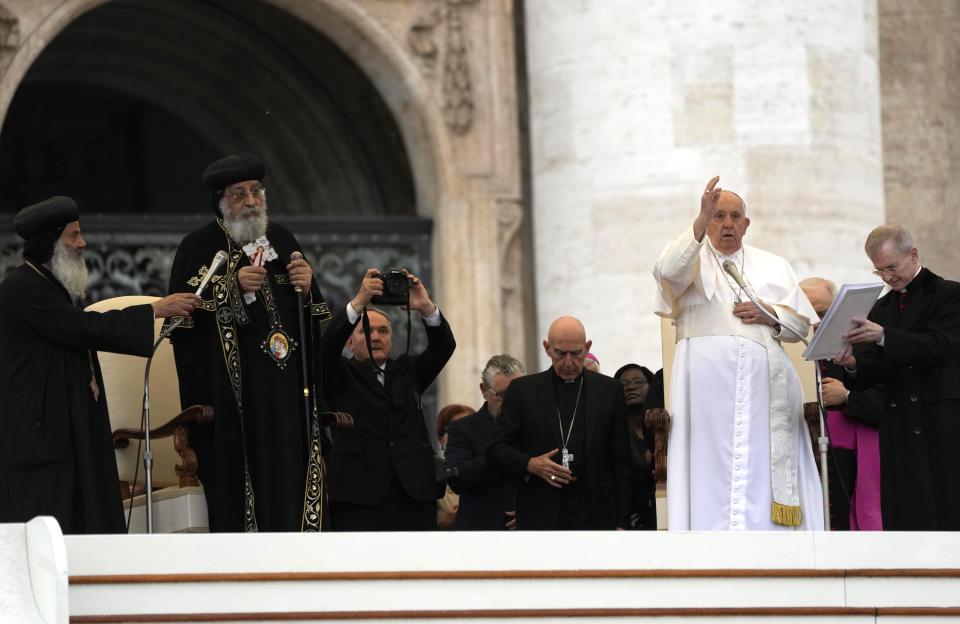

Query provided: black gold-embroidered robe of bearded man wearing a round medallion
[170,220,330,532]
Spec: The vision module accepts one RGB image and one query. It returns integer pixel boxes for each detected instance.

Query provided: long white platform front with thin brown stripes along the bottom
[66,532,960,623]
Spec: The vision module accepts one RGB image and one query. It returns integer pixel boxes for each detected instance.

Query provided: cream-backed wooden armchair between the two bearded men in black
[87,296,213,533]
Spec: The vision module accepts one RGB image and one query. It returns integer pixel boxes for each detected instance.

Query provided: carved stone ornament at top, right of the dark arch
[407,0,477,134]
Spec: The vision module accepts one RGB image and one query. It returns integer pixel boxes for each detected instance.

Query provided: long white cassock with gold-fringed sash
[654,227,824,530]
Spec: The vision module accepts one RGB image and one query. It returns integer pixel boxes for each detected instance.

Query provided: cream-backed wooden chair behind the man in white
[644,318,820,531]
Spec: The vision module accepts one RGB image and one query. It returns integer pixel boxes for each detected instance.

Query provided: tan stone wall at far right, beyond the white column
[879,0,960,279]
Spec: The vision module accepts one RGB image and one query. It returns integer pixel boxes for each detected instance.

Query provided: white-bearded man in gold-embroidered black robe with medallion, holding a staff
[163,154,330,532]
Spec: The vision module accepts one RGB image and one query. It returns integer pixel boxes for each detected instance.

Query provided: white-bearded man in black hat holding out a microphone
[0,197,199,533]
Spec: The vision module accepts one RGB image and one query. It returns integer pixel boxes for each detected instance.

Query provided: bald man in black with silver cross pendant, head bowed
[486,316,630,530]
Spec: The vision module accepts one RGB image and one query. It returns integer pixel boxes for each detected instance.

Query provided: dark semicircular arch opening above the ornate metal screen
[0,0,416,217]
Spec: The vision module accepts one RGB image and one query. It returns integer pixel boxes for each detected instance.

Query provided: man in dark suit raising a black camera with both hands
[321,269,456,531]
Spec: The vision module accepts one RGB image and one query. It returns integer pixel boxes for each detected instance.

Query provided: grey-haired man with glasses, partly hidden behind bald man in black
[446,354,524,531]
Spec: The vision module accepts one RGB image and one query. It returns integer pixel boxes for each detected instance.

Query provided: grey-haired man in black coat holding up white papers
[835,225,960,531]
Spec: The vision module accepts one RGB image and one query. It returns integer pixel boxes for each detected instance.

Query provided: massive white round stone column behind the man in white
[526,0,883,374]
